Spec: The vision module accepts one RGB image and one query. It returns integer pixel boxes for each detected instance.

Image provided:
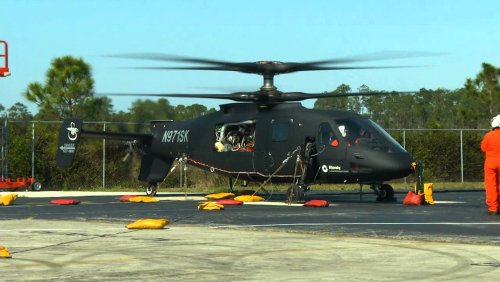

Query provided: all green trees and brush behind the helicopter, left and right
[0,56,500,189]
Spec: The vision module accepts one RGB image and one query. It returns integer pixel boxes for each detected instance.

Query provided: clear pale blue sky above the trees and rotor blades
[0,0,500,113]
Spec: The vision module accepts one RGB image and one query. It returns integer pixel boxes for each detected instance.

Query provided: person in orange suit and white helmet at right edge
[481,115,500,215]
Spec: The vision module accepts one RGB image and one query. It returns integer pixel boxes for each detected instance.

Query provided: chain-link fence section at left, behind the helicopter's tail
[1,121,148,189]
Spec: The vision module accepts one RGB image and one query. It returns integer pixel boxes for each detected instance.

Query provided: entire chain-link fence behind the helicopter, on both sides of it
[0,121,487,188]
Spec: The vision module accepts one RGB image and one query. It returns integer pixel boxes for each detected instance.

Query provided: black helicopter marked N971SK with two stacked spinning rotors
[57,54,414,201]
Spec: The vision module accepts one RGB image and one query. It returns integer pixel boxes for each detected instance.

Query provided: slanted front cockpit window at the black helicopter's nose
[336,119,405,152]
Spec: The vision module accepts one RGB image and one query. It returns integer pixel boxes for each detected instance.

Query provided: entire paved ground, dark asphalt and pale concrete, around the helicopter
[0,191,500,281]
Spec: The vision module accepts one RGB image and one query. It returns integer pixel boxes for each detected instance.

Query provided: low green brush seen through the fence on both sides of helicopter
[2,122,484,190]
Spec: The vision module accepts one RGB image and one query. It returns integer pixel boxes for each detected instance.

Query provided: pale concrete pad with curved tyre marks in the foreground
[0,219,500,281]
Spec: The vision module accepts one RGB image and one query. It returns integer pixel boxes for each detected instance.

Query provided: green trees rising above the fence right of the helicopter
[314,63,500,129]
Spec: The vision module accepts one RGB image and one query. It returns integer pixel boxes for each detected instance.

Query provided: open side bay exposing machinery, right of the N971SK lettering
[214,120,256,152]
